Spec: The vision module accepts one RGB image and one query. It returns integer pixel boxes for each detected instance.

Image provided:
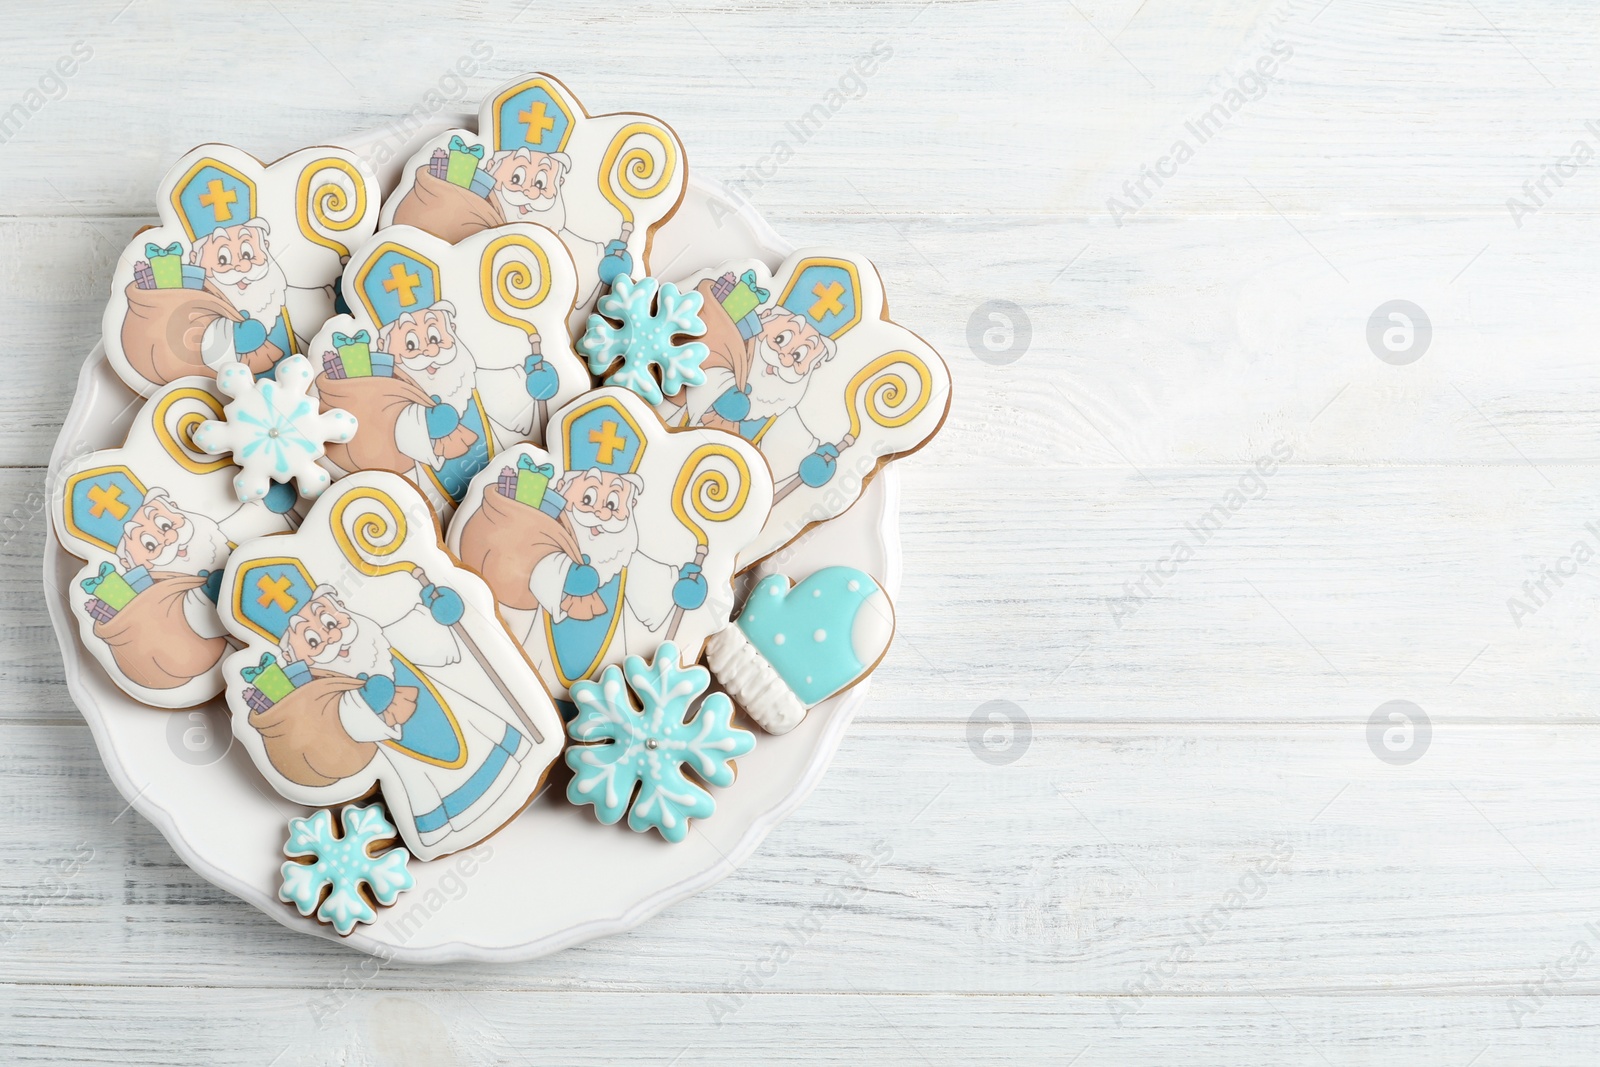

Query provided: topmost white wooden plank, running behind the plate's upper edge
[0,0,1600,220]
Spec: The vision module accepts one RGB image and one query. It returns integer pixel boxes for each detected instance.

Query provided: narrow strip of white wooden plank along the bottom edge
[0,987,1600,1067]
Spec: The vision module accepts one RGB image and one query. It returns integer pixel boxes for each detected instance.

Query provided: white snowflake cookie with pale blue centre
[194,355,355,502]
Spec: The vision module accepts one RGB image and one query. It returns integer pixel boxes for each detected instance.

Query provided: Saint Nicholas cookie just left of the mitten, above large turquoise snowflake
[450,389,773,697]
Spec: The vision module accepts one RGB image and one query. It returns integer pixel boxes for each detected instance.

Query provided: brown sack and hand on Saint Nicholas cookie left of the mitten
[461,483,605,621]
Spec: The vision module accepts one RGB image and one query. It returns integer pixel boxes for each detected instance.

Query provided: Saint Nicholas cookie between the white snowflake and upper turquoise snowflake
[310,224,590,518]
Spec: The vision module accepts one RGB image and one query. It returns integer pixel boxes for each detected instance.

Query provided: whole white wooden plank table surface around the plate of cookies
[0,0,1600,1067]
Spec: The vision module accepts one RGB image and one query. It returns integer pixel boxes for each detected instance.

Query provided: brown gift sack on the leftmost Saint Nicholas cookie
[94,571,227,689]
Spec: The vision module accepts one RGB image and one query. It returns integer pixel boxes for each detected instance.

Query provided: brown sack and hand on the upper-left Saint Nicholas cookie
[122,282,283,386]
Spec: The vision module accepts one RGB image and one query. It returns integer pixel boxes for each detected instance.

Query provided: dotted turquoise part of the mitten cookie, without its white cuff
[738,566,894,707]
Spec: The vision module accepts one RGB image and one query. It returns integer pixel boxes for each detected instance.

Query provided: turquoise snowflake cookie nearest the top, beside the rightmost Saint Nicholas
[578,275,710,405]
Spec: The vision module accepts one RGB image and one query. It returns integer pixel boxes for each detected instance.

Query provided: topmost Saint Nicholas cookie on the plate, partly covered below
[382,74,688,331]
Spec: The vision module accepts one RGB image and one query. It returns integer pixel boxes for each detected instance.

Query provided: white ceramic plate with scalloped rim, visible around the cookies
[45,115,899,963]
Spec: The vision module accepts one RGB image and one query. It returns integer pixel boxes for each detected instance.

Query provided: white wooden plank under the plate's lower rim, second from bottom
[0,717,1600,1009]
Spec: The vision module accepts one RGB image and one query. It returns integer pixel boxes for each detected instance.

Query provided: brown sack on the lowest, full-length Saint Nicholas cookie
[250,670,378,785]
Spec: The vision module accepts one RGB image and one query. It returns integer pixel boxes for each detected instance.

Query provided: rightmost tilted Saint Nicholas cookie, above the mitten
[658,248,950,568]
